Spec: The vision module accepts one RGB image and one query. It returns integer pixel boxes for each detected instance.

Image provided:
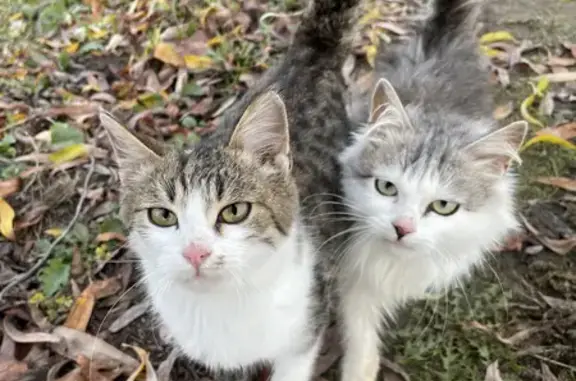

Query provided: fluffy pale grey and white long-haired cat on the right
[340,0,527,381]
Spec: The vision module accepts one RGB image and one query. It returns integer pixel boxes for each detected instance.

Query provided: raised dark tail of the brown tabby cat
[292,0,362,62]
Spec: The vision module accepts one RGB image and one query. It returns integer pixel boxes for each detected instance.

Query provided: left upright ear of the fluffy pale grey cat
[368,78,411,127]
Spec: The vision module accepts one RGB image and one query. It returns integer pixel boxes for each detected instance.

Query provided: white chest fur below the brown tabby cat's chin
[147,249,313,369]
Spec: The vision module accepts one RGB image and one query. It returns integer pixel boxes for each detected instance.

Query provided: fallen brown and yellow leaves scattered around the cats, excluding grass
[0,0,576,381]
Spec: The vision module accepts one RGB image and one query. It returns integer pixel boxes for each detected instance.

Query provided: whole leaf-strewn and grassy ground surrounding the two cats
[0,0,576,381]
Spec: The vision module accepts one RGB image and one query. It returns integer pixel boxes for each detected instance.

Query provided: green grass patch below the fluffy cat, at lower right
[391,277,521,381]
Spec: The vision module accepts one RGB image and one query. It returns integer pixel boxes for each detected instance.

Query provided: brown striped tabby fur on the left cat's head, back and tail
[103,0,360,378]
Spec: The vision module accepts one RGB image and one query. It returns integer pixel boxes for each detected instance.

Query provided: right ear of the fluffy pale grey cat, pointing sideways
[466,121,528,173]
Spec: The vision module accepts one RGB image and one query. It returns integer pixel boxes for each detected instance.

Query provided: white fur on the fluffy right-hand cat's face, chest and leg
[340,160,517,381]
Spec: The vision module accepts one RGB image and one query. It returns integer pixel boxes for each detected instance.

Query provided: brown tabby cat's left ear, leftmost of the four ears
[99,110,160,181]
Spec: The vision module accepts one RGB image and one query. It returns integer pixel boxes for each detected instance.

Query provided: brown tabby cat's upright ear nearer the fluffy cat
[229,91,291,169]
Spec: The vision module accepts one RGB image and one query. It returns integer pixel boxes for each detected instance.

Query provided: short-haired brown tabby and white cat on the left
[101,0,359,381]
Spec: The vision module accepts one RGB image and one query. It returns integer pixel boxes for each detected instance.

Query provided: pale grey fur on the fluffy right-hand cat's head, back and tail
[346,0,525,208]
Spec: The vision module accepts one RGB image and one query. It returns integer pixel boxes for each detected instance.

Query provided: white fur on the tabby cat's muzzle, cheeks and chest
[130,192,319,381]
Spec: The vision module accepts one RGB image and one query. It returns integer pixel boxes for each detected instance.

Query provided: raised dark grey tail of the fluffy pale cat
[421,0,483,54]
